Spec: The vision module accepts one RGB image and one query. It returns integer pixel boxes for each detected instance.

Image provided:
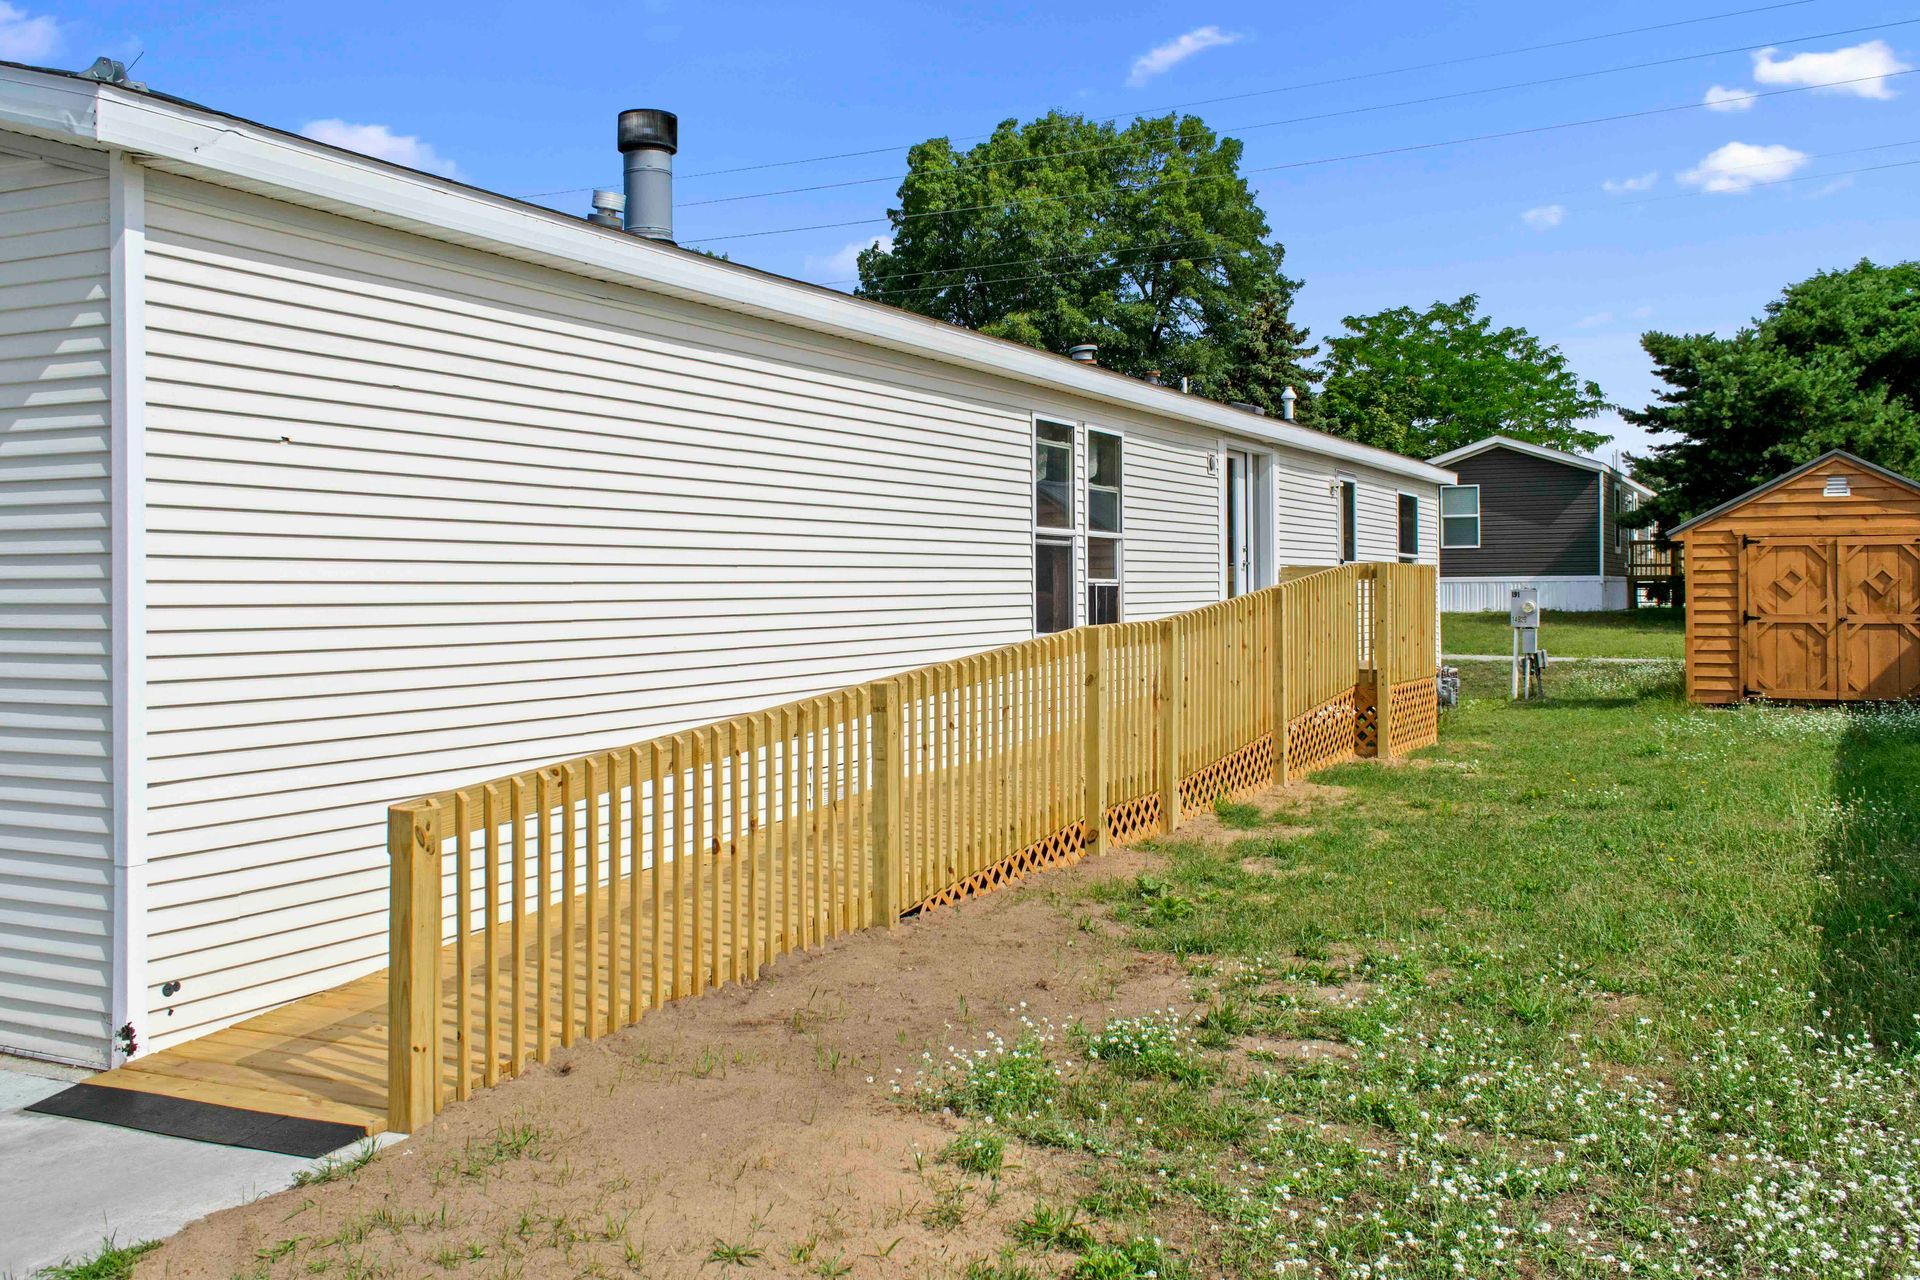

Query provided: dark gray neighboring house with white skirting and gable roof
[1432,436,1653,614]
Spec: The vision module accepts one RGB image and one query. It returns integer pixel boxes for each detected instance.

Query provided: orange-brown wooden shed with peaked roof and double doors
[1670,449,1920,702]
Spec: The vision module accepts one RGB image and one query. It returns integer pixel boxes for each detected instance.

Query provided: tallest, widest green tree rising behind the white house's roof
[856,111,1313,407]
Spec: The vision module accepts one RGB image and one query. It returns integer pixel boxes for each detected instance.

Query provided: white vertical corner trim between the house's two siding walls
[108,150,148,1065]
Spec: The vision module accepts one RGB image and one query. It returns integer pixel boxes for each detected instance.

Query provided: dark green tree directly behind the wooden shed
[1624,261,1920,528]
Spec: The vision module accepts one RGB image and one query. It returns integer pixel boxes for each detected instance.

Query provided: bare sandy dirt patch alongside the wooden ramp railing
[149,850,1196,1280]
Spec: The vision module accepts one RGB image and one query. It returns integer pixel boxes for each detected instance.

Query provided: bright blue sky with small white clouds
[18,0,1920,453]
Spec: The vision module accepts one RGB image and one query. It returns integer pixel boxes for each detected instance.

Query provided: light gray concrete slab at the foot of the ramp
[0,1061,315,1280]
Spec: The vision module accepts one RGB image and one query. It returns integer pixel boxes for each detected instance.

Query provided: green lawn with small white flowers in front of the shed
[920,667,1920,1280]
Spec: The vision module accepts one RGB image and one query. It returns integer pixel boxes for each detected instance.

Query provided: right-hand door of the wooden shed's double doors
[1837,537,1920,699]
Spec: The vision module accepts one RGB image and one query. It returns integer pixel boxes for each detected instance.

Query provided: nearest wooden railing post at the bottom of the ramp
[386,800,442,1134]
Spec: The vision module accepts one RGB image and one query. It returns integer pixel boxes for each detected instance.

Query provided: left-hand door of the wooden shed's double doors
[1740,537,1839,700]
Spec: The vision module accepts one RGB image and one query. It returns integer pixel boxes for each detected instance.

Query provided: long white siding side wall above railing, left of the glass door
[146,175,1259,1046]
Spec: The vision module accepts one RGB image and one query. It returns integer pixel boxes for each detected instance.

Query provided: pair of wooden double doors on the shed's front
[1740,537,1920,700]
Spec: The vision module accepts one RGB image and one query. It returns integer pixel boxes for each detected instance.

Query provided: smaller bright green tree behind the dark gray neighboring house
[1317,294,1607,457]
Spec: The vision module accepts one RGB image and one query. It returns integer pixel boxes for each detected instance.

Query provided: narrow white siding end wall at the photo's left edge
[0,148,113,1067]
